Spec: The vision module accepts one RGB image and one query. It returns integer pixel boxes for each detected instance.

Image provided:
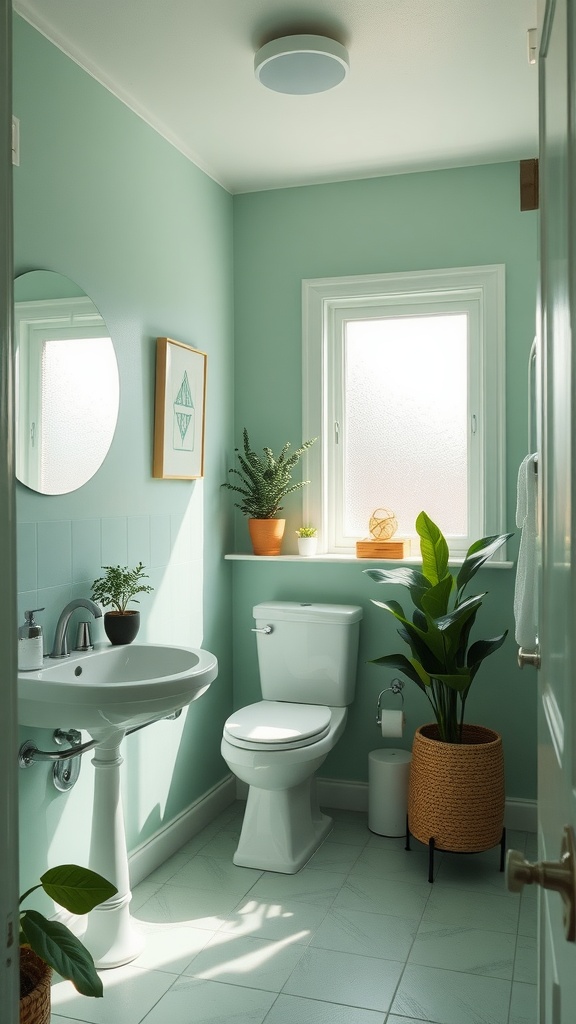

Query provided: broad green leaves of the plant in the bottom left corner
[19,864,118,996]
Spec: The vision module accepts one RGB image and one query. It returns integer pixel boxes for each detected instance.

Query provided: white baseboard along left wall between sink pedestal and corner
[128,774,236,886]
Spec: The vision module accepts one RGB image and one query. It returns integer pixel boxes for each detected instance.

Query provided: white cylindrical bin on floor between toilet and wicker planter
[368,749,412,837]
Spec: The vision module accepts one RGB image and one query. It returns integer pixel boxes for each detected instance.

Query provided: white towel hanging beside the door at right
[515,455,538,650]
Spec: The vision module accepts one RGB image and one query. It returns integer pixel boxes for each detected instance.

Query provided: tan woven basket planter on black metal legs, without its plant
[408,725,504,853]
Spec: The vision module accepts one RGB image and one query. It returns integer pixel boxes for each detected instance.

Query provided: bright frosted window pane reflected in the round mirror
[37,338,118,494]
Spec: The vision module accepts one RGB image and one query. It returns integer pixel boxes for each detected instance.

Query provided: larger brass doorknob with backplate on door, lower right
[506,825,576,942]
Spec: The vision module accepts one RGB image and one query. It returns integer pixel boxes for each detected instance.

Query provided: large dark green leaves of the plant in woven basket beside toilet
[363,512,512,743]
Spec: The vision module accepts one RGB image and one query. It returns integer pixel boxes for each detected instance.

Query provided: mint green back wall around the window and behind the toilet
[233,164,537,799]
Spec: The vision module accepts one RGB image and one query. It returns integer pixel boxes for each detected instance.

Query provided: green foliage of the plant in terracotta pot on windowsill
[224,427,316,519]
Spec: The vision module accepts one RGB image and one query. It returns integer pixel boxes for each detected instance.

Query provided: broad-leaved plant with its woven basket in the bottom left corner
[19,864,118,1024]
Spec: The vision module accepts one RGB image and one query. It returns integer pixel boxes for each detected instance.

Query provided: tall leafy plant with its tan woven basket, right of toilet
[363,512,511,864]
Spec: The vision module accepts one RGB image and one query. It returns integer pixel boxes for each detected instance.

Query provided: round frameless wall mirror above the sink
[14,270,120,495]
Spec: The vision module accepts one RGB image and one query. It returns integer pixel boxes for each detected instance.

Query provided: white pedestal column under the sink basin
[82,730,143,969]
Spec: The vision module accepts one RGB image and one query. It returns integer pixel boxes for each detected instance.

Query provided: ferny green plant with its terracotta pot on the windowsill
[223,427,316,555]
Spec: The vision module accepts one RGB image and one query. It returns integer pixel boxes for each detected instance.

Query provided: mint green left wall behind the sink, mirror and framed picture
[14,17,233,884]
